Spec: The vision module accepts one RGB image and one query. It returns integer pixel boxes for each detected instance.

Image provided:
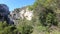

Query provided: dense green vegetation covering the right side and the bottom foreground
[0,0,60,34]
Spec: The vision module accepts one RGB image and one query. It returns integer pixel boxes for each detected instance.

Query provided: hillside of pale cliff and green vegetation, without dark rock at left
[0,0,60,34]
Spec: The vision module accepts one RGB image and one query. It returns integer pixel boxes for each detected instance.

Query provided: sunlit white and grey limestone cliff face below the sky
[11,7,33,20]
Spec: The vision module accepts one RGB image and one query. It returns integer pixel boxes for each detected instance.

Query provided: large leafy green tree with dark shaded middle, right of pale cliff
[30,0,58,26]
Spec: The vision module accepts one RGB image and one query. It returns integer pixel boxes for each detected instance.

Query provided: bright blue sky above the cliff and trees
[0,0,35,11]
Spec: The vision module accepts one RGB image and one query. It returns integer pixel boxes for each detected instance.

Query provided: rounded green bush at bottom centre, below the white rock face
[17,19,33,34]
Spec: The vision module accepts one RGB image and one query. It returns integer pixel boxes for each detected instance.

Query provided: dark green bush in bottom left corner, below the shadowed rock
[0,22,17,34]
